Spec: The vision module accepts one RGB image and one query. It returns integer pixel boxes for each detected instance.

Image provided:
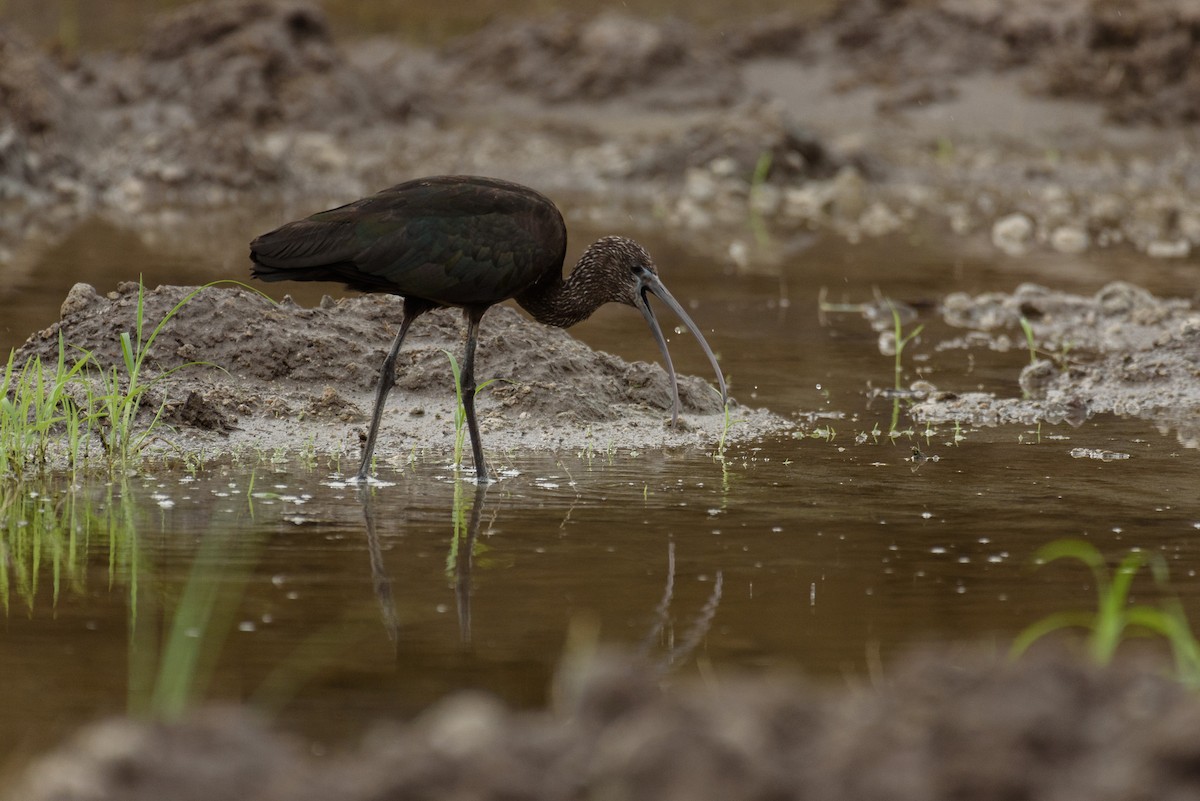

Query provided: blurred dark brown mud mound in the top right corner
[763,0,1200,126]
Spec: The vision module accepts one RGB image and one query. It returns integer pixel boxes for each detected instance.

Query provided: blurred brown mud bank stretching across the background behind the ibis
[0,0,1200,266]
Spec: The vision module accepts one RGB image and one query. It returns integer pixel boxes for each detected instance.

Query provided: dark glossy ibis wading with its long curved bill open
[250,175,727,482]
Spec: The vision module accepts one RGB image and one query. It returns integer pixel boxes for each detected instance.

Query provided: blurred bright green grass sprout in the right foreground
[1012,540,1200,688]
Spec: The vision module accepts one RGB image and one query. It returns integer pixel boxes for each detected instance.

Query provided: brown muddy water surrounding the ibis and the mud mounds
[0,206,1200,760]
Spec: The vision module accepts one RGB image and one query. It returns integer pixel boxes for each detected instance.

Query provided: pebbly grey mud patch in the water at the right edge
[913,282,1200,445]
